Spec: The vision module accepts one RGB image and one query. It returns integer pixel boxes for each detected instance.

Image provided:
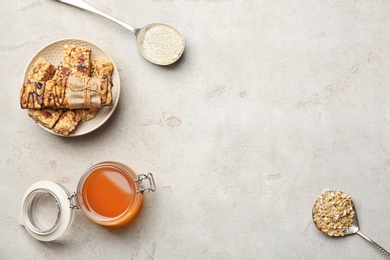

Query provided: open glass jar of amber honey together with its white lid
[19,161,156,241]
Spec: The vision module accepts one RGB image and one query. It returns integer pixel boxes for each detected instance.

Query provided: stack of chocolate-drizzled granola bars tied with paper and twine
[20,44,114,136]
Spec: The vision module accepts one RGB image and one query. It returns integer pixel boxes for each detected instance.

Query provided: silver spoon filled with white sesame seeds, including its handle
[56,0,185,65]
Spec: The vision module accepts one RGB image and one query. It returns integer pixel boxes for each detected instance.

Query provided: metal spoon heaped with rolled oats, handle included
[312,189,390,257]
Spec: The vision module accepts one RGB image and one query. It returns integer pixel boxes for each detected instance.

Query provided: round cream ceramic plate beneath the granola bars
[23,39,120,137]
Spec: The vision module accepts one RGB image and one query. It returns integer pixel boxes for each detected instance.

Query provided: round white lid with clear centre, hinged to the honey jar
[19,181,74,241]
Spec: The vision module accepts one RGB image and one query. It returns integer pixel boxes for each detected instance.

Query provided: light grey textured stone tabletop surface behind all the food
[0,0,390,259]
